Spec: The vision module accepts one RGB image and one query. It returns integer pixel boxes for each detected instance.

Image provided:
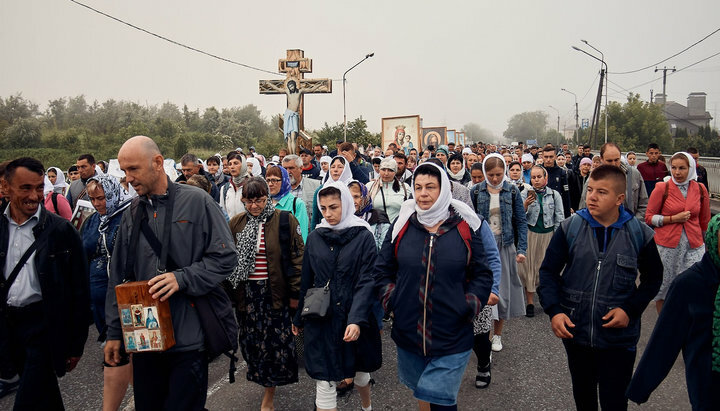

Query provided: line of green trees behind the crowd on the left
[0,93,380,169]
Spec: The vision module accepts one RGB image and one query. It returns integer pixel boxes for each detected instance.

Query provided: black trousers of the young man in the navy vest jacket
[563,340,636,411]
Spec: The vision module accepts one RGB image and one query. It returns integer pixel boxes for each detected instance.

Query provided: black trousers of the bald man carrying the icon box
[132,350,208,411]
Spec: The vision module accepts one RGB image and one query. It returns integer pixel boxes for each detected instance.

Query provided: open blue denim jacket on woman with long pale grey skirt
[470,181,527,255]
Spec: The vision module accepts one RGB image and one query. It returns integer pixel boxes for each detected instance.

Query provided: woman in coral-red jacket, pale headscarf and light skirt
[645,152,710,313]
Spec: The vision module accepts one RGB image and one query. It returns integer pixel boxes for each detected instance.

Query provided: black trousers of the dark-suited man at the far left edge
[2,302,65,410]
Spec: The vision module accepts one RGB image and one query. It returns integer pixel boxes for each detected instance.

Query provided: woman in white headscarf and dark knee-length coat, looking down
[293,179,382,410]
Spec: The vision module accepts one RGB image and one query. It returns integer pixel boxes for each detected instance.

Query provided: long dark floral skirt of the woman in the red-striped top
[238,280,298,387]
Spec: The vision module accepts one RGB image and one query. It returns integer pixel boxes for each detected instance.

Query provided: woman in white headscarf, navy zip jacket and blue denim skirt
[375,163,493,410]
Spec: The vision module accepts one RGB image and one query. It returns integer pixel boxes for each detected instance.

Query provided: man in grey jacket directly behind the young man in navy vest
[580,143,648,221]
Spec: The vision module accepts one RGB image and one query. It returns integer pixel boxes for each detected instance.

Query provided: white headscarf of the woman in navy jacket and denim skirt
[390,162,482,241]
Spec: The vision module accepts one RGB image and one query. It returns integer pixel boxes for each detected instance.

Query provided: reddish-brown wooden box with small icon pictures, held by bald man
[115,281,175,352]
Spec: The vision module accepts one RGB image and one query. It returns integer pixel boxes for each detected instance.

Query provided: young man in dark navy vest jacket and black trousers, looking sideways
[538,165,662,410]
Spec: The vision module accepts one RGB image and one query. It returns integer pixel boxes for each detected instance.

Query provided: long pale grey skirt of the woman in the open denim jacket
[495,236,525,320]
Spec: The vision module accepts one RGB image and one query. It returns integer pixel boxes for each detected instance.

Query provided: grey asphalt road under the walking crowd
[0,305,690,410]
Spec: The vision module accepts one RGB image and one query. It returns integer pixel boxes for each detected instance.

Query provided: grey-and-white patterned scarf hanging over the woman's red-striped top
[228,186,275,288]
